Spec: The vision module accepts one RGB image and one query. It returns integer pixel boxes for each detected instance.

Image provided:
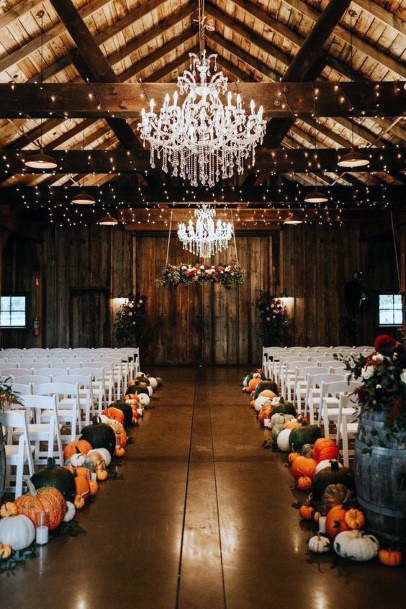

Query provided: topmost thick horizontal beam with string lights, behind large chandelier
[0,81,406,119]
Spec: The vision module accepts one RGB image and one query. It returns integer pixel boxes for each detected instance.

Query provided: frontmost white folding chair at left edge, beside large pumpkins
[0,410,34,499]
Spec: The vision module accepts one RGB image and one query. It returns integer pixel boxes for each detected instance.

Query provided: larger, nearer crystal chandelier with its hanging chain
[138,0,266,186]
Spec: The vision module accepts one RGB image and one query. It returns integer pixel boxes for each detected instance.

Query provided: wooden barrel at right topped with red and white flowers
[344,334,406,541]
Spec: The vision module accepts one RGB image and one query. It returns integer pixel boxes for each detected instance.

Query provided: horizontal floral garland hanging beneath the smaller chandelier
[156,263,245,290]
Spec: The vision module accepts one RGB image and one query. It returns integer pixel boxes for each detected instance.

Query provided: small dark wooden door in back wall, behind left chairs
[69,288,110,349]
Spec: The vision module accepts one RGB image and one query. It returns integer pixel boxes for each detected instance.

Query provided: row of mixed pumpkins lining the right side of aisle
[239,371,402,567]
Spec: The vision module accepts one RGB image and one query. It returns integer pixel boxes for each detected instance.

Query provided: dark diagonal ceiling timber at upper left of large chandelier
[50,0,142,151]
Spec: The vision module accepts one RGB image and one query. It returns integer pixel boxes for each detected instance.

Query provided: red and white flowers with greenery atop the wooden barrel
[337,334,406,431]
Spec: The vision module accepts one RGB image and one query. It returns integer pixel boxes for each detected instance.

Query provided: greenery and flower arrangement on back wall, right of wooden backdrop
[256,291,291,347]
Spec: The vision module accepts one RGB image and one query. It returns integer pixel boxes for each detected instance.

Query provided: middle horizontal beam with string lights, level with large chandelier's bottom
[0,147,406,174]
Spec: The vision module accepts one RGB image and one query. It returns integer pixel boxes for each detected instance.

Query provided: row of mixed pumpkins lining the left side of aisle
[0,373,162,560]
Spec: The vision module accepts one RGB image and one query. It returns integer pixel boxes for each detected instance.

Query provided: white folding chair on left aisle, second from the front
[14,395,63,465]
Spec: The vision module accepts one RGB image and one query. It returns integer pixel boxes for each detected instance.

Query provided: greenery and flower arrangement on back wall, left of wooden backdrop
[114,294,147,347]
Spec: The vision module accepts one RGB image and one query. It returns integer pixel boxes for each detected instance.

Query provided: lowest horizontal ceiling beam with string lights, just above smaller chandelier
[0,180,406,209]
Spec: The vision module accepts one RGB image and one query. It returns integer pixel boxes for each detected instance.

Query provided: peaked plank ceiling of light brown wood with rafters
[0,0,406,226]
